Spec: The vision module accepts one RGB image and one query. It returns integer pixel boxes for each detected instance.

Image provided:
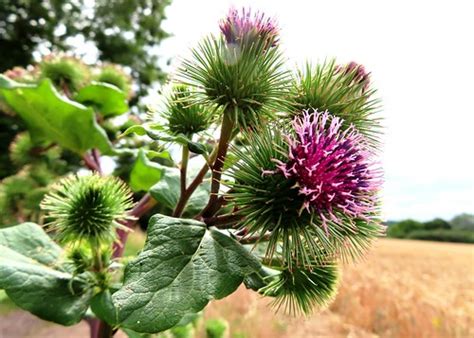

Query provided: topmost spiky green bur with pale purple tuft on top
[177,8,289,128]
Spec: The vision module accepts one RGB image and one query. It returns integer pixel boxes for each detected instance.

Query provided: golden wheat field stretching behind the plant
[0,239,474,338]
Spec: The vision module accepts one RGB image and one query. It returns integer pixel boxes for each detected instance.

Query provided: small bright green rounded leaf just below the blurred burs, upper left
[74,82,129,117]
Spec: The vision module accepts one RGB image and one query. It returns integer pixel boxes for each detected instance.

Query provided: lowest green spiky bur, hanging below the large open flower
[259,262,339,315]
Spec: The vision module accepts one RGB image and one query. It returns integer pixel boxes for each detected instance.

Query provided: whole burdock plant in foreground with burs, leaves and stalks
[0,9,382,337]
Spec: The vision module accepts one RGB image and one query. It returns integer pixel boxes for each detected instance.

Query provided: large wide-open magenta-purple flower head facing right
[278,110,382,233]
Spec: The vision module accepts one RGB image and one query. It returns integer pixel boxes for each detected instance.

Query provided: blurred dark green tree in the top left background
[0,0,171,94]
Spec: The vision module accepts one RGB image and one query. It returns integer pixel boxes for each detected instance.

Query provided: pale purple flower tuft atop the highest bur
[219,8,278,47]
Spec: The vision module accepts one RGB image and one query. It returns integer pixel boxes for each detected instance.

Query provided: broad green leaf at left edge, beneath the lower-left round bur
[0,223,92,325]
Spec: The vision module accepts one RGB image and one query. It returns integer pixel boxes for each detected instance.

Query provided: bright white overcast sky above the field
[159,0,474,220]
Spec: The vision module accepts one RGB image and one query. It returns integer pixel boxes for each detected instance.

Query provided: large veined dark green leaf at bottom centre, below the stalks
[112,215,261,333]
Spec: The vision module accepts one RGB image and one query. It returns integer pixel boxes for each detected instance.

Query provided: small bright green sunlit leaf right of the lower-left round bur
[130,149,168,191]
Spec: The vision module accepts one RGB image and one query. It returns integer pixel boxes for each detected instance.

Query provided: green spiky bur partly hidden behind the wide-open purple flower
[291,60,381,149]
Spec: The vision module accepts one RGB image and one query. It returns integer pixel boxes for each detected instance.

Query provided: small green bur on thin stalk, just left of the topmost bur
[160,84,215,137]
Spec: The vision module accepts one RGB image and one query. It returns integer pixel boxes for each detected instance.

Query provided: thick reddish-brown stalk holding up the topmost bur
[201,111,234,218]
